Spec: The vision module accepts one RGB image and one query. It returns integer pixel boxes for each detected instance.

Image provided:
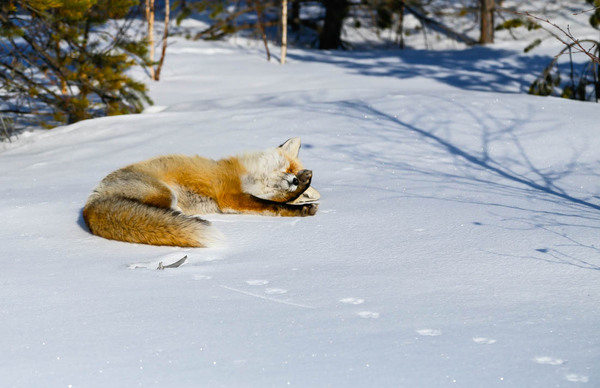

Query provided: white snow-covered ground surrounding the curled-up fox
[0,31,600,387]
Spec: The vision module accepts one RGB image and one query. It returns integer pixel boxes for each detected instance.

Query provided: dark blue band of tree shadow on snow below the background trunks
[288,46,576,93]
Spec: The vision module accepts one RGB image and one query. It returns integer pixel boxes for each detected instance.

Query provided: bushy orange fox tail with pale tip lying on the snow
[83,196,222,247]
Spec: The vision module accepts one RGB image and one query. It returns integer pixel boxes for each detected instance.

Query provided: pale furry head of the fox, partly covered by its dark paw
[240,137,318,202]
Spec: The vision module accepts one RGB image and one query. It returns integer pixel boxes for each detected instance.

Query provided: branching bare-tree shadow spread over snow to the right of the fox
[304,97,600,270]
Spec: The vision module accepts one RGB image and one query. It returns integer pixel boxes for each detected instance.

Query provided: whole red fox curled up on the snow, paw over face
[83,138,320,247]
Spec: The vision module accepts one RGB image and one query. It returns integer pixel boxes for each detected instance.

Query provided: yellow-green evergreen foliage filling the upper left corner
[0,0,151,127]
